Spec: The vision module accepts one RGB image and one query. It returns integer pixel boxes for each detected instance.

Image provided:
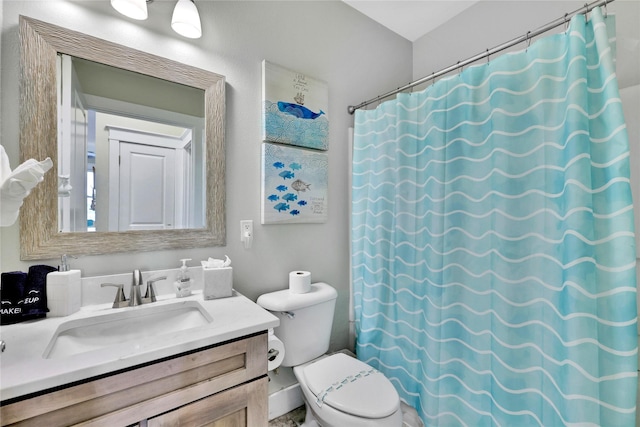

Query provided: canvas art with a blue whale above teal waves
[262,61,329,150]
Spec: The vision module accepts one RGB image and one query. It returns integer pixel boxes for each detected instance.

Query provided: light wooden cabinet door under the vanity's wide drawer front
[147,377,268,427]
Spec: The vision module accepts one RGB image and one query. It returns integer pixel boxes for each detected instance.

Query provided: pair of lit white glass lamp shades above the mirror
[111,0,202,39]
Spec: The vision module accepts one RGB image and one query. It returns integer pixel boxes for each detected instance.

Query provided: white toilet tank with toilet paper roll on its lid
[256,282,338,366]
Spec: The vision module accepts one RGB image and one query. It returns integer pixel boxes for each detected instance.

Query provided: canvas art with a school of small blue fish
[261,142,329,224]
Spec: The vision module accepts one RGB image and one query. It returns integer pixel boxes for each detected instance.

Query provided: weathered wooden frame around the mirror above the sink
[20,16,226,260]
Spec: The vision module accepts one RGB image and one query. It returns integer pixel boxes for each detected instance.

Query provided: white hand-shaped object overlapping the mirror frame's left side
[0,145,53,227]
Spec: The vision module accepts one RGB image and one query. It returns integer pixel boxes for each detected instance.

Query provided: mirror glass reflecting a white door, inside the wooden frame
[57,54,206,232]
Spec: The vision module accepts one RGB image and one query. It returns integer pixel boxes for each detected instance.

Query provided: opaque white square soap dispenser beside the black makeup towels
[47,255,82,317]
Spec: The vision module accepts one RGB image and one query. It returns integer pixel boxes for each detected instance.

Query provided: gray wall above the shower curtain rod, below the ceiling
[413,0,640,88]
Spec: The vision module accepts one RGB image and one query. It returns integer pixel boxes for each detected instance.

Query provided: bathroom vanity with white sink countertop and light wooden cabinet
[0,292,279,426]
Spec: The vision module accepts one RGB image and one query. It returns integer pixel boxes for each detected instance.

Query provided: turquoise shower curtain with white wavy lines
[352,9,637,427]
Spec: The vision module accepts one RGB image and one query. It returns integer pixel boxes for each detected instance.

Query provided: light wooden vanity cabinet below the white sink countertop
[0,332,268,427]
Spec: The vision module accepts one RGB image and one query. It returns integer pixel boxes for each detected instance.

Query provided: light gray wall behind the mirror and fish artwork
[0,0,412,349]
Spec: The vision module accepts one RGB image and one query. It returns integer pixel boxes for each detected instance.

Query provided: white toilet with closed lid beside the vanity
[257,283,403,427]
